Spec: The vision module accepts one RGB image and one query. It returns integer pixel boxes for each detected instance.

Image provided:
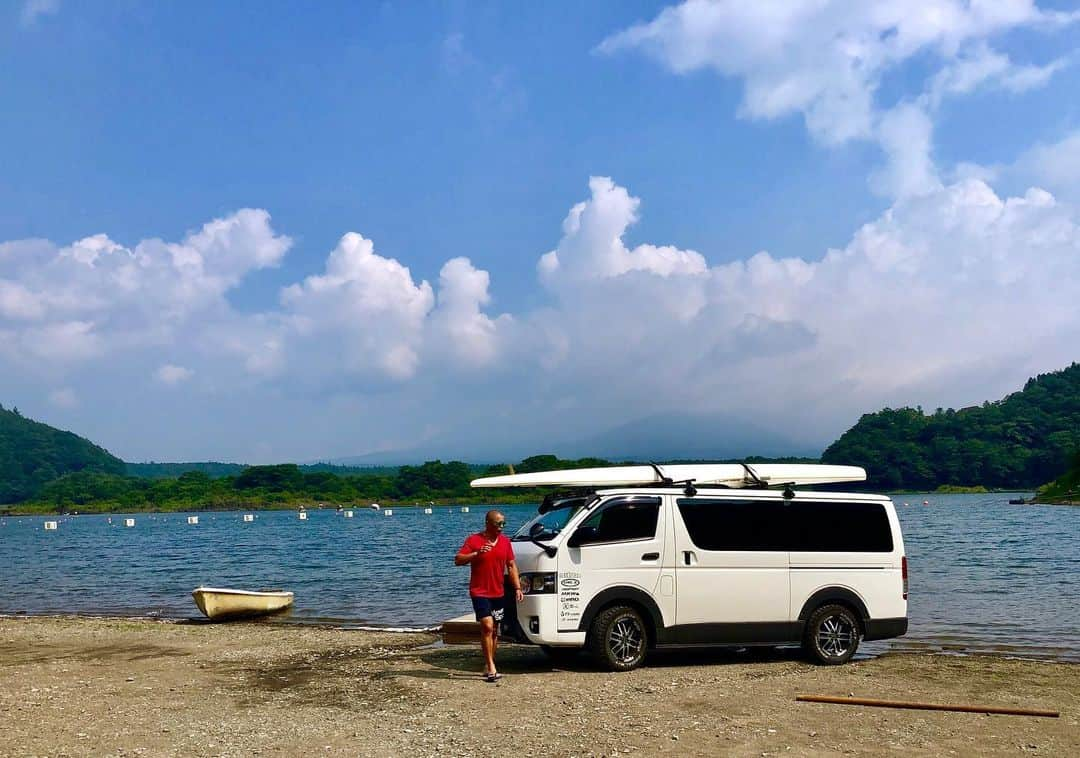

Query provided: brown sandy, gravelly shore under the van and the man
[0,618,1080,757]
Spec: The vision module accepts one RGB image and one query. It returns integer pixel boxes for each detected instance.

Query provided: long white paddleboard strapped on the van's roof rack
[472,463,866,488]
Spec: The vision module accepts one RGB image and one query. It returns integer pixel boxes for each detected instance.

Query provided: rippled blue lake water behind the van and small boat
[0,492,1080,661]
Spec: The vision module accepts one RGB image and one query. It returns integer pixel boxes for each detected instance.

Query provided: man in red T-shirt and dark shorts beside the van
[454,511,522,681]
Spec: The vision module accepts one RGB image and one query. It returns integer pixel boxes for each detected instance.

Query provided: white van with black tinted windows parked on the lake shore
[474,465,907,671]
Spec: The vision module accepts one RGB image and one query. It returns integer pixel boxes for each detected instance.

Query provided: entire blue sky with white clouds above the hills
[0,0,1080,461]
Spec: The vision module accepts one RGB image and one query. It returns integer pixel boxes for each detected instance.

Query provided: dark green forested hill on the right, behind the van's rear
[822,363,1080,490]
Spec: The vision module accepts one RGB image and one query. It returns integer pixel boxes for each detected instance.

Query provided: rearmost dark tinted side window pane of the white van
[788,499,892,553]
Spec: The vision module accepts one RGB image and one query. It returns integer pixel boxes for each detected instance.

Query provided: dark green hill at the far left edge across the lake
[0,406,125,503]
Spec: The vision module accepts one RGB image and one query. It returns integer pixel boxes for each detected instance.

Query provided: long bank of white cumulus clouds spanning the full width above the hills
[0,177,1080,459]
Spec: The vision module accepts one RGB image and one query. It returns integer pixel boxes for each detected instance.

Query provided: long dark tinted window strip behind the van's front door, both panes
[676,498,892,553]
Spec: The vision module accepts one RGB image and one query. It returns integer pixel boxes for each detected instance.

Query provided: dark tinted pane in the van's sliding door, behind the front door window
[676,498,787,551]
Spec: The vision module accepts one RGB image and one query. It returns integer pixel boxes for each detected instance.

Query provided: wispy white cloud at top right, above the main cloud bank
[597,0,1080,193]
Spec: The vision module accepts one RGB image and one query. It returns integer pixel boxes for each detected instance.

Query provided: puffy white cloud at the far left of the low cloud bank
[0,209,292,362]
